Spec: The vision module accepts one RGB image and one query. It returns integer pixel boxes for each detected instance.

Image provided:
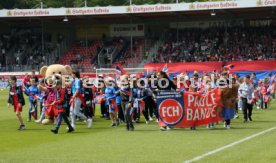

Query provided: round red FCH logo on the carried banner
[158,99,184,126]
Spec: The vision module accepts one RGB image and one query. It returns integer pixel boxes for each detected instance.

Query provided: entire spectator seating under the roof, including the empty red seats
[0,25,276,72]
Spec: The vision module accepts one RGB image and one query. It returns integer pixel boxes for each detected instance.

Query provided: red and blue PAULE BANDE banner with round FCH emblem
[157,89,223,127]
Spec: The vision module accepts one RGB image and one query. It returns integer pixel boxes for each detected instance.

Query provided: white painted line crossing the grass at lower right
[184,127,276,163]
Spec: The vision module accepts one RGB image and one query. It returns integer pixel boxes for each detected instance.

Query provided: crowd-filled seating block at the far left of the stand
[0,28,57,71]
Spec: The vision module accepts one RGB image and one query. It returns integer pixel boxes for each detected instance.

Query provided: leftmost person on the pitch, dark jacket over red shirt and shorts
[8,76,25,131]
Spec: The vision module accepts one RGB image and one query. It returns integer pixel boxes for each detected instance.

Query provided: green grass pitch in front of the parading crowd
[0,91,276,163]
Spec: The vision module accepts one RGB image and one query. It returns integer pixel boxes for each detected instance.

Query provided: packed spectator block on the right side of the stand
[151,26,276,63]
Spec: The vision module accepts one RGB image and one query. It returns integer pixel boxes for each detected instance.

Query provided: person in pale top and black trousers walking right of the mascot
[238,75,254,123]
